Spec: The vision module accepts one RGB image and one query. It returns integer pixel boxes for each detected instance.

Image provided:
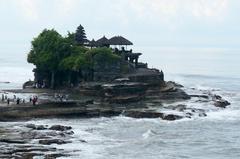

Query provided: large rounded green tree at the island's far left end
[28,29,70,88]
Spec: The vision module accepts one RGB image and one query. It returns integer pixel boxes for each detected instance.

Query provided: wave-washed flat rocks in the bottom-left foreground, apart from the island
[0,124,78,159]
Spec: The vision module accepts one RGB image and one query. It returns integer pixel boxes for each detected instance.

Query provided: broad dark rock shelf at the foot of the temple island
[0,79,230,121]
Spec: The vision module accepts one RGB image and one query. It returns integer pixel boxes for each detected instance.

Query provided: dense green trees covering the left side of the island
[27,25,120,88]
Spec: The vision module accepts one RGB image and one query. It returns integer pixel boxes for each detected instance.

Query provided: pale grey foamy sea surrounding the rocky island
[0,47,240,159]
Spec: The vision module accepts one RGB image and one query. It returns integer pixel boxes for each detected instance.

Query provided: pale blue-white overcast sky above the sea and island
[0,0,240,56]
